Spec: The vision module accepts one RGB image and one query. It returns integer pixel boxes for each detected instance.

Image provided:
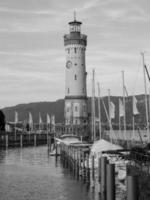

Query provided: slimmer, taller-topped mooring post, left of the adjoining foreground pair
[100,157,107,200]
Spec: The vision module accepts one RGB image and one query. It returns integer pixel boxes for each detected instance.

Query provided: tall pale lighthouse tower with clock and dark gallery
[64,16,88,134]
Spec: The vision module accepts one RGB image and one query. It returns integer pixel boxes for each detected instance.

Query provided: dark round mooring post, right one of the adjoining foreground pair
[106,164,115,200]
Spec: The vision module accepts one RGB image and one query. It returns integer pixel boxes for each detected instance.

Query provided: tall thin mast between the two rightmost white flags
[122,71,126,140]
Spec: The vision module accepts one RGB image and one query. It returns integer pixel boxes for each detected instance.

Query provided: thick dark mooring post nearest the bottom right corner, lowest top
[127,176,138,200]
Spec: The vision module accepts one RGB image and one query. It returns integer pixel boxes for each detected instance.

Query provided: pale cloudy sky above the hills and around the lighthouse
[0,0,150,108]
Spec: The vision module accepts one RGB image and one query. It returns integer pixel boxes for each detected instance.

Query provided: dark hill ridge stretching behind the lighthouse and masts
[3,95,146,127]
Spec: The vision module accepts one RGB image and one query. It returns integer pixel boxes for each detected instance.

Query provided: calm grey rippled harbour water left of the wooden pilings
[0,146,98,200]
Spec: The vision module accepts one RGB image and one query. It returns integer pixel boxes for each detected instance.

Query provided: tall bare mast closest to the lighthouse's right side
[92,69,96,141]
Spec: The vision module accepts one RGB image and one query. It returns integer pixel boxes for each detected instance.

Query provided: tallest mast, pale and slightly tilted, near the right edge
[141,52,150,142]
